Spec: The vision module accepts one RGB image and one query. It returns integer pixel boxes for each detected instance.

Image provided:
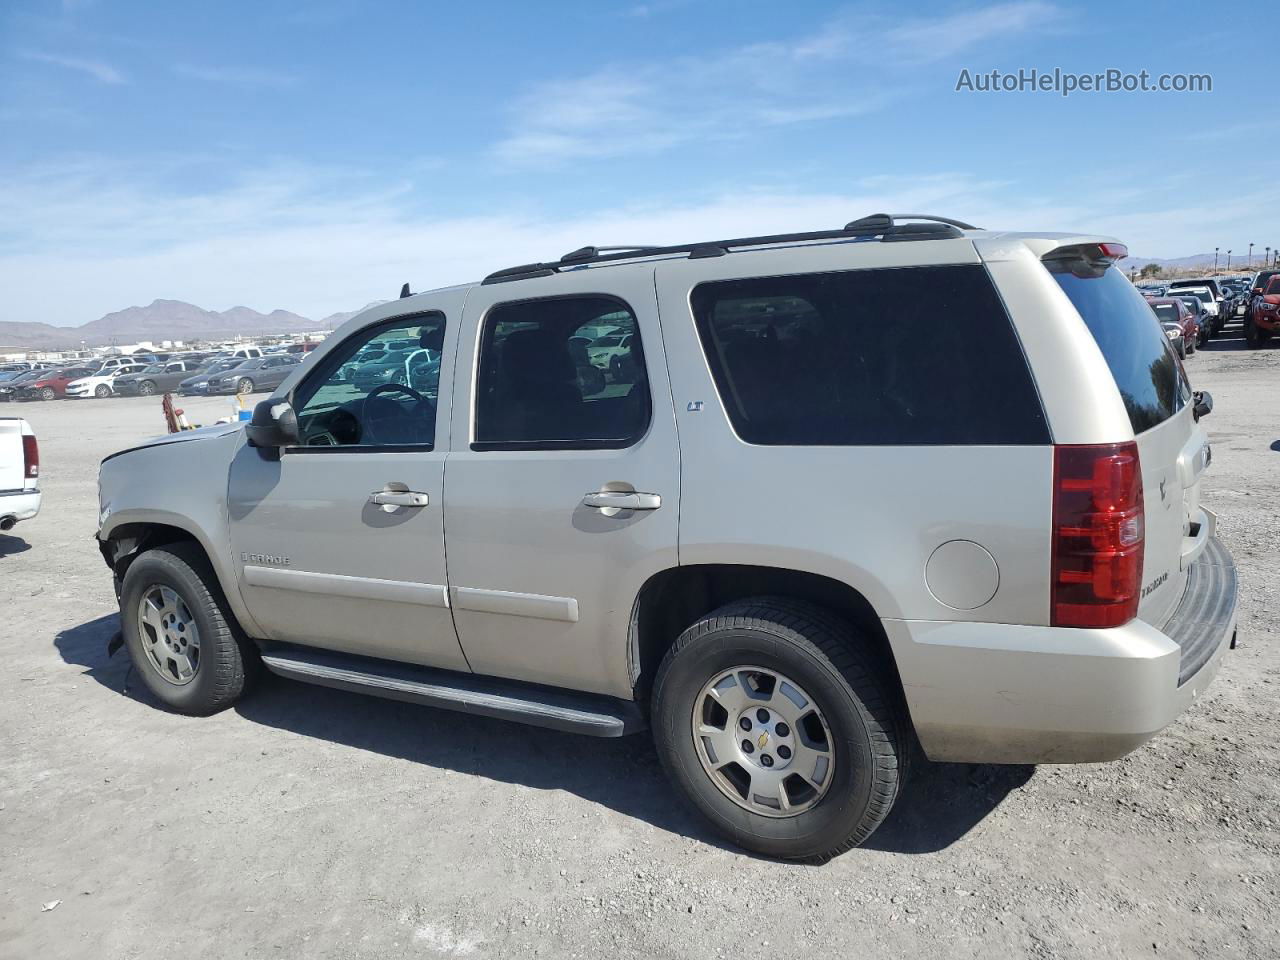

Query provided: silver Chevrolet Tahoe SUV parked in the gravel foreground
[97,215,1235,861]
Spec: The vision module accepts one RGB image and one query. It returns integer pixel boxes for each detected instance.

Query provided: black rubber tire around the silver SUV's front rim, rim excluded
[120,543,261,717]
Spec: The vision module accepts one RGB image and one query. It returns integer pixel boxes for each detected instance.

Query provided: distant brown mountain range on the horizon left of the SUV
[0,300,378,349]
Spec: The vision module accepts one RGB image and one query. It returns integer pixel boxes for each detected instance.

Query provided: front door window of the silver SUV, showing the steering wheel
[290,314,444,449]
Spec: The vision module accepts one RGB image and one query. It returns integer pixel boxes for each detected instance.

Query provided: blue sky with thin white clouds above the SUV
[0,0,1280,324]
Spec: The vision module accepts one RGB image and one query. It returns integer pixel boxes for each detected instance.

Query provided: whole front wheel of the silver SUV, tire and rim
[120,543,259,716]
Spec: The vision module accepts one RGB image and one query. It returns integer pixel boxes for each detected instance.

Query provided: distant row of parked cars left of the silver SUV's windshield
[0,347,307,401]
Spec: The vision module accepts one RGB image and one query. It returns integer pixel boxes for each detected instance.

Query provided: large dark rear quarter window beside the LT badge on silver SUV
[691,266,1044,445]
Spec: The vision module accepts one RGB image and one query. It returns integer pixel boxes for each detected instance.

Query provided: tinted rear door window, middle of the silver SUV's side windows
[472,296,650,449]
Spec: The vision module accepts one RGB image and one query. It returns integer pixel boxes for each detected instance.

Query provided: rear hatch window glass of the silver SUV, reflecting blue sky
[1047,271,1190,434]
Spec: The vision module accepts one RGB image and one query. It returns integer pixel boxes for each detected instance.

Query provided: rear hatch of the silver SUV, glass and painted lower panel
[1044,259,1213,627]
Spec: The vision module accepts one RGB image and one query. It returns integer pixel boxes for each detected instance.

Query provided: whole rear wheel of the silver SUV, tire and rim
[653,598,909,863]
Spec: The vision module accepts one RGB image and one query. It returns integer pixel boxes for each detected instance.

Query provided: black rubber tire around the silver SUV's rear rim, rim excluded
[652,596,911,863]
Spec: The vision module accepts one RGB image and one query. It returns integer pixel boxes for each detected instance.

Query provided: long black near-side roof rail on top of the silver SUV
[483,214,978,284]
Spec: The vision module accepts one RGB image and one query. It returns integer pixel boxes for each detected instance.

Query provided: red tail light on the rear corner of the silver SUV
[1050,440,1146,627]
